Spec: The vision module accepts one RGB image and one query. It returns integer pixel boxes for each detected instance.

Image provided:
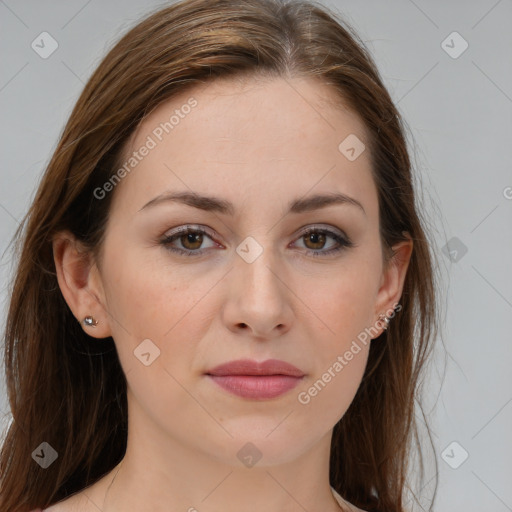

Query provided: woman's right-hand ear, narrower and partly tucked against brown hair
[374,232,413,335]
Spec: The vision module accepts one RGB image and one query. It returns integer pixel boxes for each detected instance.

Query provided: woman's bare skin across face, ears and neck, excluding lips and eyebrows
[51,78,412,512]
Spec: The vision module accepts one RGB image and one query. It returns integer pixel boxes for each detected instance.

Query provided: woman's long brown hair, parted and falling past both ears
[0,0,438,512]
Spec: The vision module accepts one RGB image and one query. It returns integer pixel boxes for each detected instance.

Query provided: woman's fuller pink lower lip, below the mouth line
[208,375,302,400]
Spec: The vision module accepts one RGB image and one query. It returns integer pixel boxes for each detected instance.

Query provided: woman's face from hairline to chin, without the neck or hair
[68,75,405,466]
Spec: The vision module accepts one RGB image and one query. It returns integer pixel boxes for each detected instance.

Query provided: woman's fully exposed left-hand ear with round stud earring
[52,231,111,338]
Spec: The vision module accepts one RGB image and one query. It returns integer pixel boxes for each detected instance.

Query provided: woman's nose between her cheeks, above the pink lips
[223,243,293,339]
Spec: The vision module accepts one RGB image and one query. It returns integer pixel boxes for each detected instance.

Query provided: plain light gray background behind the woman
[0,0,512,512]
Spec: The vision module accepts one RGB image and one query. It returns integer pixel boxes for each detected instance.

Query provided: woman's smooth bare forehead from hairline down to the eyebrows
[112,73,373,214]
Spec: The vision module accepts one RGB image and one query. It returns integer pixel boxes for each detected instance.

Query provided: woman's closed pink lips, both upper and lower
[206,359,305,400]
